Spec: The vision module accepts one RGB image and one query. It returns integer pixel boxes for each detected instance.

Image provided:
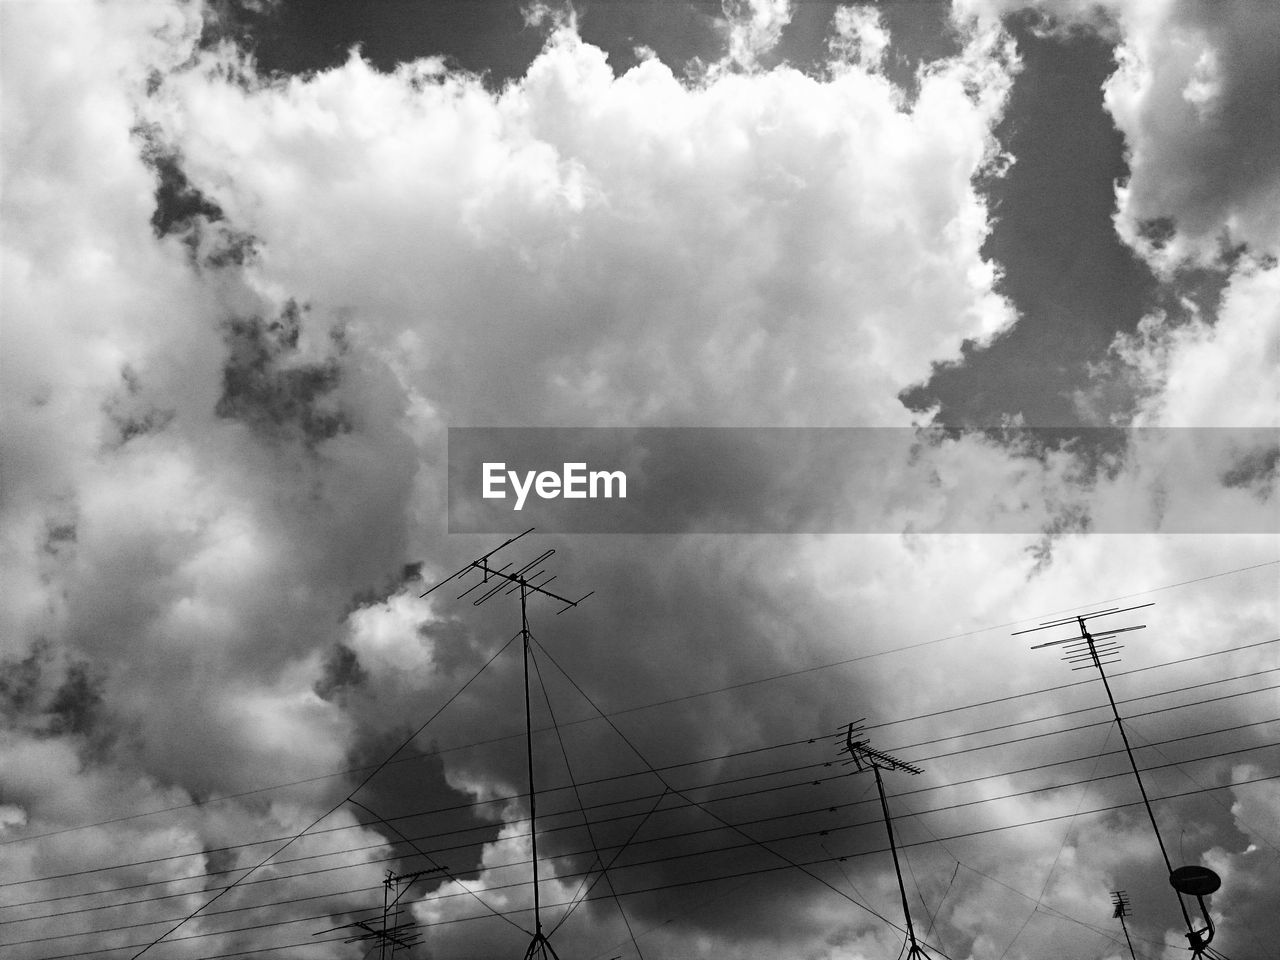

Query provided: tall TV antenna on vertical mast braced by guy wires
[422,527,594,960]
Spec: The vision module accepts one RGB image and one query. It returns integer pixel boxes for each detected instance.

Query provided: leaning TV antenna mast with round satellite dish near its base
[1012,603,1222,957]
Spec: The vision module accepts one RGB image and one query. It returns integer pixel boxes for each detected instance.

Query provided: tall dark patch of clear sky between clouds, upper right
[901,13,1229,426]
